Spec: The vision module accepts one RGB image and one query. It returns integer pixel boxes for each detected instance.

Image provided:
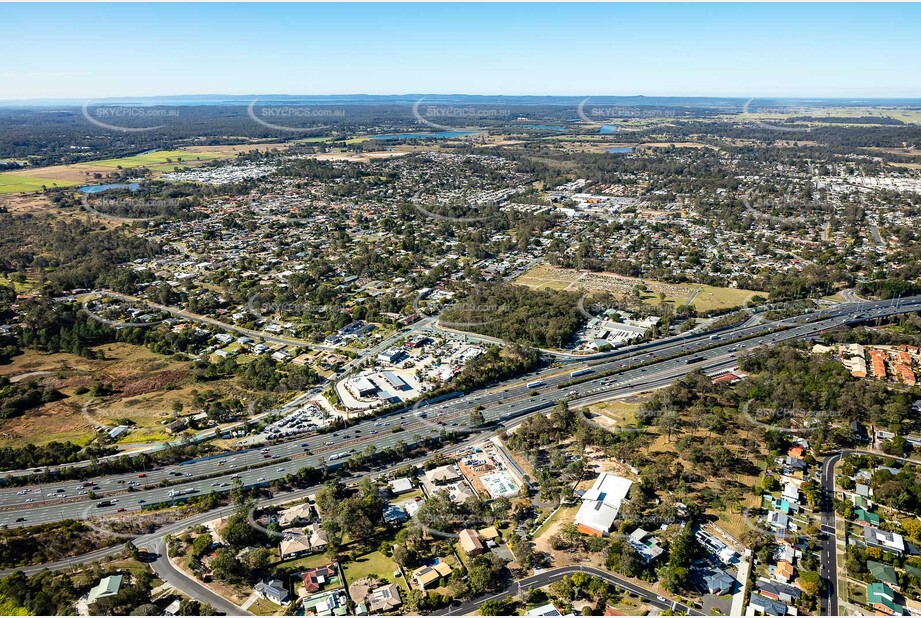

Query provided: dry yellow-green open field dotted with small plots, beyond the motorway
[515,264,758,312]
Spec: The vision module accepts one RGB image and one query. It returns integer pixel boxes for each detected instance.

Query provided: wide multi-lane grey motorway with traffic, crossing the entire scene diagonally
[0,297,921,527]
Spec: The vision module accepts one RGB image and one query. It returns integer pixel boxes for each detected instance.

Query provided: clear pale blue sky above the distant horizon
[0,3,921,99]
